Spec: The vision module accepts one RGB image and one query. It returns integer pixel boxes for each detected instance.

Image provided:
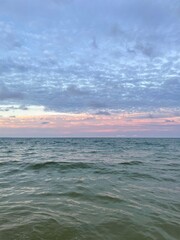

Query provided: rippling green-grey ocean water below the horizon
[0,138,180,240]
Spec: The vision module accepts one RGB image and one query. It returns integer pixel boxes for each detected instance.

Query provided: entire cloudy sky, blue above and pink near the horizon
[0,0,180,137]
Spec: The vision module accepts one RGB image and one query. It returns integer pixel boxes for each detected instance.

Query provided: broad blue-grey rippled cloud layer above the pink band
[0,0,180,115]
